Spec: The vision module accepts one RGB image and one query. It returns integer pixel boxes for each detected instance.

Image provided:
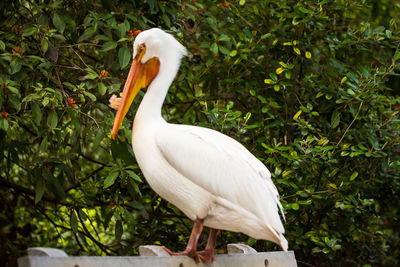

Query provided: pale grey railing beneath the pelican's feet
[18,244,297,267]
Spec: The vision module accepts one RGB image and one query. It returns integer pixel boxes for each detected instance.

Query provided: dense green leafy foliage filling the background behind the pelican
[0,0,400,266]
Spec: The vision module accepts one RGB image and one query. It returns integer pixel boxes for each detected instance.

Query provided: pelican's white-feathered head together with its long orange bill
[111,28,187,139]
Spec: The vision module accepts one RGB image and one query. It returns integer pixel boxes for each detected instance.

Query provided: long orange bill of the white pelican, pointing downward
[111,47,160,139]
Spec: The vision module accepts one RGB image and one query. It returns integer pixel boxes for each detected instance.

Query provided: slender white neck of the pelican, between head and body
[135,55,180,121]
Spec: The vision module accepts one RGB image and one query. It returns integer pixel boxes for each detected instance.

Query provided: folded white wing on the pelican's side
[156,124,284,236]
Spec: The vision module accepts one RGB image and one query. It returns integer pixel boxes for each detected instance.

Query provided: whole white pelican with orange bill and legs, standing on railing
[110,28,288,262]
